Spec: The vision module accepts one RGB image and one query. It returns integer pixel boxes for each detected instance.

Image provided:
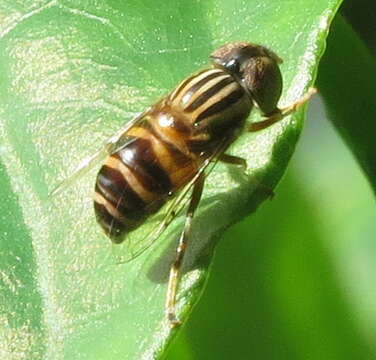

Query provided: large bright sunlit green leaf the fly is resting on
[0,0,340,359]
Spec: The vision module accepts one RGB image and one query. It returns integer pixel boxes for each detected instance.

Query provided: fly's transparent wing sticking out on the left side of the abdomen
[49,109,150,196]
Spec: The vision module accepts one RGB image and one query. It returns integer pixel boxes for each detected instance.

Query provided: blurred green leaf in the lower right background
[167,101,376,360]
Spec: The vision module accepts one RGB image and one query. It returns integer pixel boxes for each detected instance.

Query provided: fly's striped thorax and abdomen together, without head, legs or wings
[94,69,252,242]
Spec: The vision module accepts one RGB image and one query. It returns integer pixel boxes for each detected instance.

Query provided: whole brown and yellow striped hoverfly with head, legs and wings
[54,42,315,326]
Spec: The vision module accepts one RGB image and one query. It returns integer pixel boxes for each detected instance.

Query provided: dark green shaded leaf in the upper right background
[318,17,376,191]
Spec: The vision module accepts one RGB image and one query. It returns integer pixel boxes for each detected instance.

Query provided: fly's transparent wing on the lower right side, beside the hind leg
[112,136,228,263]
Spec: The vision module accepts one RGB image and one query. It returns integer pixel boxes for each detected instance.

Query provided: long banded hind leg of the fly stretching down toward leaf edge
[166,173,205,327]
